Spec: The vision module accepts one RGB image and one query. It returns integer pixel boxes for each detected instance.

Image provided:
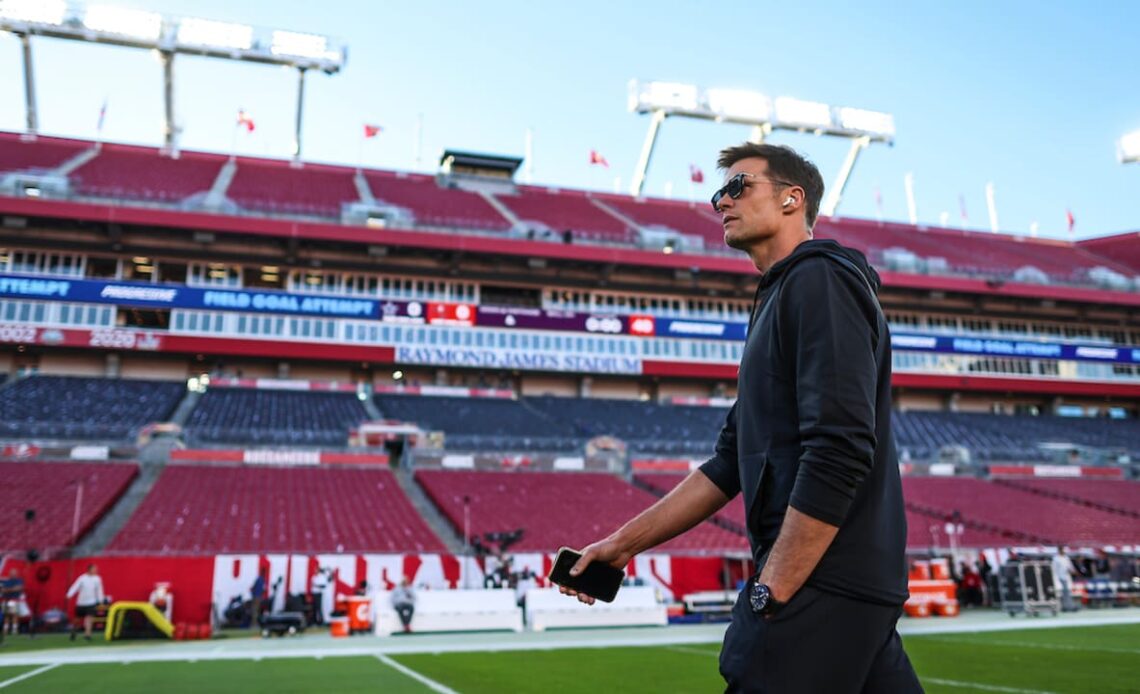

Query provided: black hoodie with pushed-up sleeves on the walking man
[701,240,907,605]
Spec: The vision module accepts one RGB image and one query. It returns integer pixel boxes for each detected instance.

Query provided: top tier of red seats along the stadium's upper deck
[0,133,1140,276]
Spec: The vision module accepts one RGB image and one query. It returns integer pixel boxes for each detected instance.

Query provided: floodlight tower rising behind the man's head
[629,80,895,217]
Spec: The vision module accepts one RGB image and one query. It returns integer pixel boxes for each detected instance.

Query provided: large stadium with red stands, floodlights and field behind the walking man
[0,2,1140,693]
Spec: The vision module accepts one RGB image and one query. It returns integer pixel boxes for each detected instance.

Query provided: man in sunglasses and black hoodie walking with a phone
[563,144,922,694]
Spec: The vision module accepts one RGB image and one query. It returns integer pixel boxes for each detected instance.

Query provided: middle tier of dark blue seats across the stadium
[0,376,1140,462]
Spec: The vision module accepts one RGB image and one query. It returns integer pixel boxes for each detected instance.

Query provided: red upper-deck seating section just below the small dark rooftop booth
[365,171,511,232]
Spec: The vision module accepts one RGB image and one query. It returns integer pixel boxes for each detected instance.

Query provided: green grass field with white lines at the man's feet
[0,624,1140,694]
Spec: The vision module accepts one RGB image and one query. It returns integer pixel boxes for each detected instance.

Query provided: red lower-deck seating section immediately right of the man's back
[903,477,1140,544]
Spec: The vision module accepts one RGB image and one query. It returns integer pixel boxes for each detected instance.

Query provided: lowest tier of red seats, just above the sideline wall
[0,462,1140,554]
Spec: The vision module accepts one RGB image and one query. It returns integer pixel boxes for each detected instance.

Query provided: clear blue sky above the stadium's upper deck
[0,0,1140,238]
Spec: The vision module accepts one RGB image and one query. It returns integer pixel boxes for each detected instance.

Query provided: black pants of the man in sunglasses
[720,586,922,694]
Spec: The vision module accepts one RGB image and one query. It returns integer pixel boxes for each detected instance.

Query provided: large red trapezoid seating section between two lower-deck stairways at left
[108,465,445,554]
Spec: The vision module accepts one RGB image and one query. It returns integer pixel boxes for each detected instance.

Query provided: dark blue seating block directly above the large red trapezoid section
[186,389,368,447]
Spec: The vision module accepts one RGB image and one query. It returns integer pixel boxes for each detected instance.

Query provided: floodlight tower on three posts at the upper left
[0,0,347,157]
